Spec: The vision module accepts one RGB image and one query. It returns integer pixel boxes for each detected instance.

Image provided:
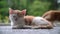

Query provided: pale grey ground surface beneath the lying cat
[0,26,60,34]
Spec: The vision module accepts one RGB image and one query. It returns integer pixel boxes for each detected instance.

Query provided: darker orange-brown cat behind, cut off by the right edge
[42,10,60,24]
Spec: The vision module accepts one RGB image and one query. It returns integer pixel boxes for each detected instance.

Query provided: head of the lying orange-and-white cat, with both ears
[9,8,26,21]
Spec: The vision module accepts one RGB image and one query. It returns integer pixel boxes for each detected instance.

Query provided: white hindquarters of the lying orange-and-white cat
[32,17,53,28]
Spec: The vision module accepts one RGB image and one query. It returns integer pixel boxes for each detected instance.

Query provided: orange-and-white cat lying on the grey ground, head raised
[9,8,52,28]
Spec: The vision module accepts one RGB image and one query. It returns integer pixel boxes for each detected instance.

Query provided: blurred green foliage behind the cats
[0,0,60,24]
